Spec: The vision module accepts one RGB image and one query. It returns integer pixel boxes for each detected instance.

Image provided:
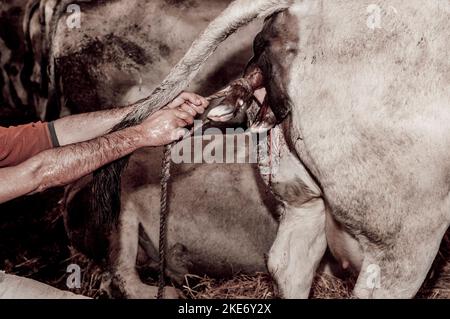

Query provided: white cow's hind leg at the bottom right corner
[354,214,448,299]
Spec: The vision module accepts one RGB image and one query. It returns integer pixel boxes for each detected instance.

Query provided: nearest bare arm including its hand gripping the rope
[0,94,204,203]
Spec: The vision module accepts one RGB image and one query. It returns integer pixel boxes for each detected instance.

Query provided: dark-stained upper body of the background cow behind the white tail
[54,0,258,113]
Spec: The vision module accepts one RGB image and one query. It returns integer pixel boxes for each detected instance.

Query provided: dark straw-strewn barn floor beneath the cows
[0,190,450,299]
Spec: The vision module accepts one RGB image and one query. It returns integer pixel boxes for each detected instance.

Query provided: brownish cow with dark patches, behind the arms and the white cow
[0,0,277,298]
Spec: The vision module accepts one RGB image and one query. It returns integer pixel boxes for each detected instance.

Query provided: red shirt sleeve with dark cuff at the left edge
[0,122,53,168]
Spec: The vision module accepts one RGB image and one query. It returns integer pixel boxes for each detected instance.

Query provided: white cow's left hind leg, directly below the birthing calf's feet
[268,152,327,298]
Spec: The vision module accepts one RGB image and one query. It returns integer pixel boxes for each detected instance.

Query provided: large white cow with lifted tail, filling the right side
[91,0,450,298]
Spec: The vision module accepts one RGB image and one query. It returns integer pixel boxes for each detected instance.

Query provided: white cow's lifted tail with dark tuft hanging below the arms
[91,0,295,231]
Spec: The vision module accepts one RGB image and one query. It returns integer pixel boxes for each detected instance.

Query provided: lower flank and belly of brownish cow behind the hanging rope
[122,137,278,277]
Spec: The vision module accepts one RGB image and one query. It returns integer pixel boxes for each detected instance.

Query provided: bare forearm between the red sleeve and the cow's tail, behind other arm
[55,106,133,146]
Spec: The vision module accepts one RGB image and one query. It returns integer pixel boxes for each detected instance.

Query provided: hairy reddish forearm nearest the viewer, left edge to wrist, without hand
[0,127,146,203]
